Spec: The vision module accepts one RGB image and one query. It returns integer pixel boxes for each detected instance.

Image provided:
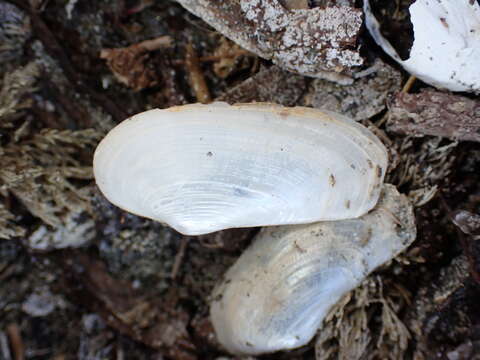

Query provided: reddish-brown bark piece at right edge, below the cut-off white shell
[387,90,480,141]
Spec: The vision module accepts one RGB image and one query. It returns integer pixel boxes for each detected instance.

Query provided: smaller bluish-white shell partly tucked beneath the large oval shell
[210,185,416,355]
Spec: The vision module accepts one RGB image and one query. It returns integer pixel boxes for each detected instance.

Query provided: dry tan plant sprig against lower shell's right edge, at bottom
[315,276,410,360]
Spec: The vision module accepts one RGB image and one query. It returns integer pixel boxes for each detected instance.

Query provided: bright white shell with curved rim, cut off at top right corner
[364,0,480,92]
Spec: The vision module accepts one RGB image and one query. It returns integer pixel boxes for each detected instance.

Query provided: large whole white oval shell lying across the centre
[93,103,387,235]
